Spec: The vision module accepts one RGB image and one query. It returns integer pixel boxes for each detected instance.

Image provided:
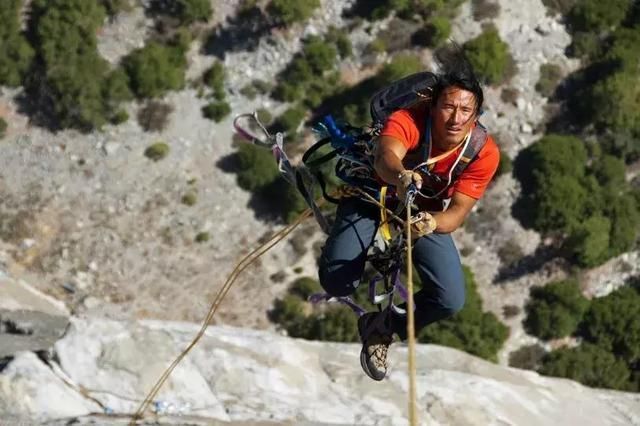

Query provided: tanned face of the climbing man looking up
[431,86,476,149]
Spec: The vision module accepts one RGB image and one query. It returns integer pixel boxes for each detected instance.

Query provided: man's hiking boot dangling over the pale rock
[358,311,393,381]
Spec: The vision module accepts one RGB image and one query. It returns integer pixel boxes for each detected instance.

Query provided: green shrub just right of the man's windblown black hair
[463,26,515,85]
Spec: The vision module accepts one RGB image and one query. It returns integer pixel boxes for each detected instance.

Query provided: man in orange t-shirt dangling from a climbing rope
[319,51,500,380]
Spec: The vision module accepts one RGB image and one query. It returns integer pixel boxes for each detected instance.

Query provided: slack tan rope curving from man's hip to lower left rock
[129,209,312,426]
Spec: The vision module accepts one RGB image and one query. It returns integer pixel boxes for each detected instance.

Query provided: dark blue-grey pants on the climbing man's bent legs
[318,198,464,340]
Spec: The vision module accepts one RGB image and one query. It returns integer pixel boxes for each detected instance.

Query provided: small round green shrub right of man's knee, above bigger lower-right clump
[524,280,589,340]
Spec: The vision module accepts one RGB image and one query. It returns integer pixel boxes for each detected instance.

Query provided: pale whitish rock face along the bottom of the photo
[0,318,640,426]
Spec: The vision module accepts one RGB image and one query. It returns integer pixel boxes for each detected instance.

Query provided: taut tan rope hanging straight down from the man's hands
[406,205,418,426]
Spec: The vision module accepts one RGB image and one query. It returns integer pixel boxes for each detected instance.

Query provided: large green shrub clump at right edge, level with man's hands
[514,135,640,266]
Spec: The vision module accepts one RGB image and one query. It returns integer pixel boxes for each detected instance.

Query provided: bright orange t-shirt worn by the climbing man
[380,108,500,200]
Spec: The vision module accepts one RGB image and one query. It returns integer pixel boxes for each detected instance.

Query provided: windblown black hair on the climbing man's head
[431,42,484,115]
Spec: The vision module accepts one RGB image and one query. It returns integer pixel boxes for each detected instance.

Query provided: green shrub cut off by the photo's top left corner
[0,0,34,87]
